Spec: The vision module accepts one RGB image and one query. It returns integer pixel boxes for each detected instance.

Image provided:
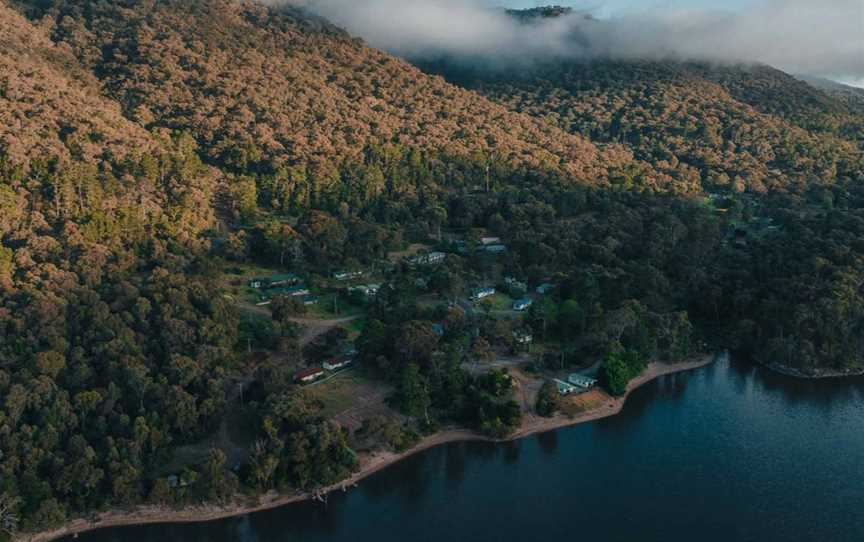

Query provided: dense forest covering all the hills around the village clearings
[0,0,864,540]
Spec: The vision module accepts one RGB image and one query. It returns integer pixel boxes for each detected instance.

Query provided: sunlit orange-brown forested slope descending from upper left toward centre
[10,0,628,184]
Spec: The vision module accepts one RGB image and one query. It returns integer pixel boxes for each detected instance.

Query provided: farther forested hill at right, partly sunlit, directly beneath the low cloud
[424,61,864,198]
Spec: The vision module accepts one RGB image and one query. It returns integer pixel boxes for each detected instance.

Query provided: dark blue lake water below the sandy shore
[69,359,864,542]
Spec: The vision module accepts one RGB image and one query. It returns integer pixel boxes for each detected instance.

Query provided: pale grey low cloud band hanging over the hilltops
[292,0,864,79]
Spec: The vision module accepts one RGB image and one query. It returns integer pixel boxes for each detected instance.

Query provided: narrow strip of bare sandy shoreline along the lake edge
[13,354,716,542]
